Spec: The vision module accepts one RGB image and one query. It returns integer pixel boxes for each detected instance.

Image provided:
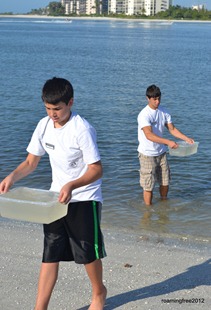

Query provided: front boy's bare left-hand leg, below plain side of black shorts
[34,263,59,310]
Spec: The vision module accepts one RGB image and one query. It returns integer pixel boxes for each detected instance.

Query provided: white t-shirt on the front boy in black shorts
[27,112,102,202]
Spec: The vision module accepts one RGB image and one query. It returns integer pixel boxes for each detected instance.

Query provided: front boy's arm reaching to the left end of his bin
[0,154,41,193]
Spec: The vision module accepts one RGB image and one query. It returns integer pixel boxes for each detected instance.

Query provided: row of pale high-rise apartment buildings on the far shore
[61,0,172,16]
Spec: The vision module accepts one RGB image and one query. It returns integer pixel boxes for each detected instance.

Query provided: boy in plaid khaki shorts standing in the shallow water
[137,85,194,205]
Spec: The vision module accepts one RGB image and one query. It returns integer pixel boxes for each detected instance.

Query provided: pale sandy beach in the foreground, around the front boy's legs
[0,219,211,310]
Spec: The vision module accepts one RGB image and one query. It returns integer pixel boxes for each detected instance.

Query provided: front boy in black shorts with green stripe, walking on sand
[0,78,106,310]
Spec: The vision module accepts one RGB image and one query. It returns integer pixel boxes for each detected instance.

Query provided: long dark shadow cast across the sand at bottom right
[77,257,211,310]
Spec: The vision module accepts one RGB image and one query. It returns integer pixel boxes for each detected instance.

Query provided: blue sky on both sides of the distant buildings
[0,0,211,14]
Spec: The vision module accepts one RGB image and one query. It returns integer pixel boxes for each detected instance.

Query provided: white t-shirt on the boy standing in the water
[138,105,172,156]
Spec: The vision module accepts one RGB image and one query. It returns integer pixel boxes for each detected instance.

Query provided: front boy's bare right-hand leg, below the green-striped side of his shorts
[84,259,107,310]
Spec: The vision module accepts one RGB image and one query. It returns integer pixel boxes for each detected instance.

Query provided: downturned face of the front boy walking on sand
[45,98,73,128]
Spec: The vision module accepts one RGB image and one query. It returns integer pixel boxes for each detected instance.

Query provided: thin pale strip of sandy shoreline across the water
[0,14,211,23]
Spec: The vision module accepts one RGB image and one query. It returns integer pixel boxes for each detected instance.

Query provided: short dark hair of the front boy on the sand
[41,77,74,105]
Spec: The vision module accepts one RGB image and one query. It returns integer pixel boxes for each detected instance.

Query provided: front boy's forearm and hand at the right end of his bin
[59,161,103,203]
